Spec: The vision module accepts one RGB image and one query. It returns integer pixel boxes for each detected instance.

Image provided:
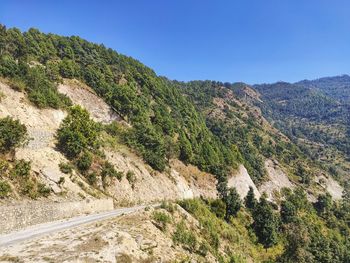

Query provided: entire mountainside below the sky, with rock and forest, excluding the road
[0,26,350,262]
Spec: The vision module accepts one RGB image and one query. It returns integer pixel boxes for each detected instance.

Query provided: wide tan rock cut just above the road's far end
[106,150,217,204]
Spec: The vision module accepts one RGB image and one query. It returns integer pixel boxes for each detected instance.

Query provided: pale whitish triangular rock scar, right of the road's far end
[227,165,260,199]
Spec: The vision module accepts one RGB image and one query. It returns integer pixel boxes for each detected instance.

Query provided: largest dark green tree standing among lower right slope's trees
[253,196,279,249]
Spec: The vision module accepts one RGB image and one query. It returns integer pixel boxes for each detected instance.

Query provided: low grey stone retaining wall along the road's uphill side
[0,199,113,234]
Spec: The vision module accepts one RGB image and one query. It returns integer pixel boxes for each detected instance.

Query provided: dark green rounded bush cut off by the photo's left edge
[0,117,27,153]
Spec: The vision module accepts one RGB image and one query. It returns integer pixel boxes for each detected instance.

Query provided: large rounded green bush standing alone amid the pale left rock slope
[57,106,99,159]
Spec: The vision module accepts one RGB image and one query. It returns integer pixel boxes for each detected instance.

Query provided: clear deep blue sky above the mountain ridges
[0,0,350,84]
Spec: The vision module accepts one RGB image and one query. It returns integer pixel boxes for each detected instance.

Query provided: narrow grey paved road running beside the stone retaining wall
[0,206,145,248]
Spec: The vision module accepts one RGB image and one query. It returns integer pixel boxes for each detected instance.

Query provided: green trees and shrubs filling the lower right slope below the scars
[178,188,350,263]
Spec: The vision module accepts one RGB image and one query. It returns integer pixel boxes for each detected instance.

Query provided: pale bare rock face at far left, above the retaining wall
[0,83,87,200]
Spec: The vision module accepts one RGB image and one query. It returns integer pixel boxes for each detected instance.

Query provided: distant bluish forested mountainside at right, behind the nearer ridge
[254,80,350,186]
